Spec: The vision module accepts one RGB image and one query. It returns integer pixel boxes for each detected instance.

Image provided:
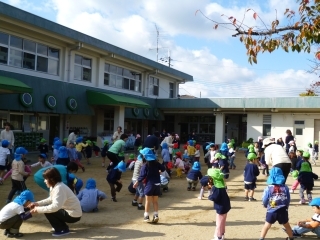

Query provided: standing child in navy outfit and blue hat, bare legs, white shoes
[133,148,165,223]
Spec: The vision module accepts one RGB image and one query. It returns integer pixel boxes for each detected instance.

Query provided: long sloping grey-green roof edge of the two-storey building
[0,2,193,82]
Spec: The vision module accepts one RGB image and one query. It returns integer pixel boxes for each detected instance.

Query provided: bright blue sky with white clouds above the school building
[2,0,318,97]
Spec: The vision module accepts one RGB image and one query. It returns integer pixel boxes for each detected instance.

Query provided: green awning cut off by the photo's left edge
[0,76,32,94]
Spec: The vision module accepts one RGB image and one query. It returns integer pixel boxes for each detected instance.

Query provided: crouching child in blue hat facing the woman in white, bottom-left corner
[0,190,34,238]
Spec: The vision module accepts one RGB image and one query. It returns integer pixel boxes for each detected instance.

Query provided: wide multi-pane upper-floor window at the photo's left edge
[0,32,59,75]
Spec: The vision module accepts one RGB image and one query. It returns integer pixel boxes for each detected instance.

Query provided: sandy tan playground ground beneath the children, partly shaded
[0,152,320,240]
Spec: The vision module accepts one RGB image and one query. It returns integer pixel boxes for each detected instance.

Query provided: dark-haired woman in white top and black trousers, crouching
[28,167,82,237]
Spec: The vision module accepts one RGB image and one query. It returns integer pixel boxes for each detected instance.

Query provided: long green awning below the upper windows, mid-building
[87,90,150,108]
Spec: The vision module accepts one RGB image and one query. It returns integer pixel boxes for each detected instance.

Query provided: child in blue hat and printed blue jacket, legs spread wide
[260,167,294,240]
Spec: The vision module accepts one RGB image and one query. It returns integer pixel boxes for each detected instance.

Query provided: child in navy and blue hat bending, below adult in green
[107,161,126,202]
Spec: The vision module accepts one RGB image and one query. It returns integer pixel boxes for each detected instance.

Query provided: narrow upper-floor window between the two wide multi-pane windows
[74,53,91,82]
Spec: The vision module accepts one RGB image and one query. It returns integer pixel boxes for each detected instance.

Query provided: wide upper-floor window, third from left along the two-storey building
[104,63,141,92]
